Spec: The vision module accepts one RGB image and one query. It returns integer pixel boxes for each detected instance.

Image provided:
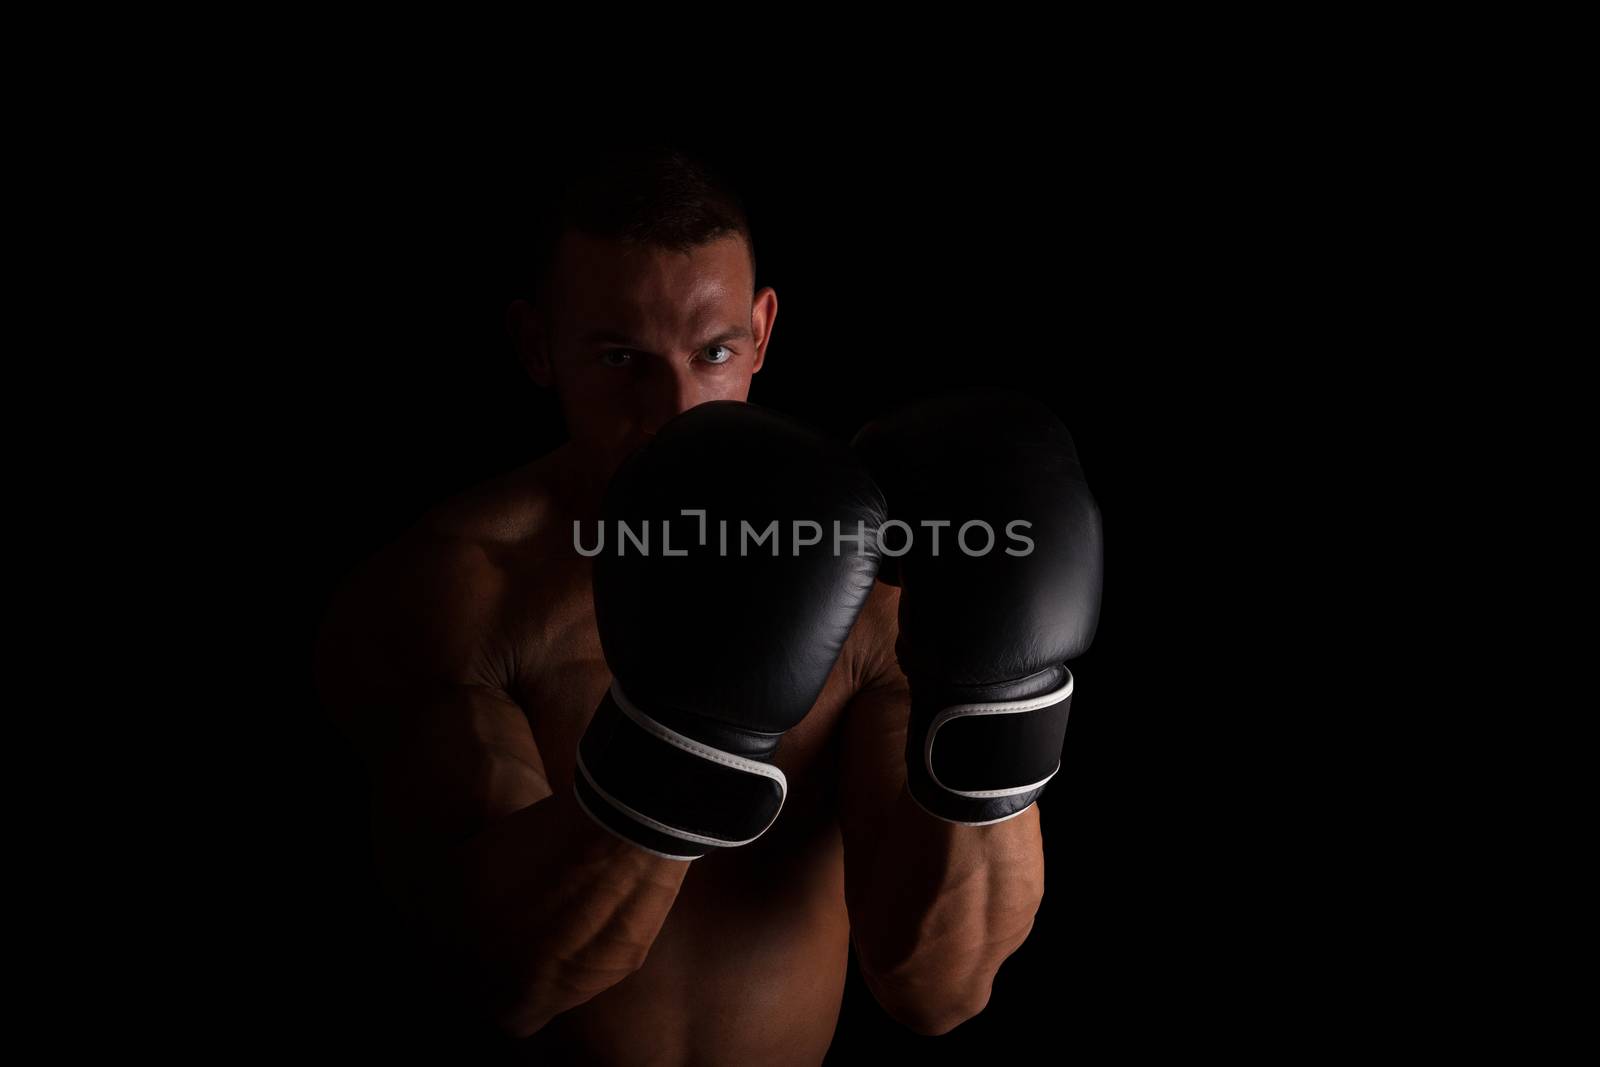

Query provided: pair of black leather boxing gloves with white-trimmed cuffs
[573,390,1101,859]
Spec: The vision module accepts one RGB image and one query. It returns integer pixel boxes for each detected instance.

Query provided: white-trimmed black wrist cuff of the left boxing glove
[573,680,789,859]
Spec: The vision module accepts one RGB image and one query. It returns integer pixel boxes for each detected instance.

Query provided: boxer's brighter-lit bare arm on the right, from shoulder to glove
[840,584,1045,1035]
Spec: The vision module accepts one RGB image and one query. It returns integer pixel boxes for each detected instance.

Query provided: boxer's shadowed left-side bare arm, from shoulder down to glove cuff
[317,539,688,1037]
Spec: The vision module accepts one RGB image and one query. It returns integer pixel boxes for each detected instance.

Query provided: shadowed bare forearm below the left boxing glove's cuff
[403,780,690,1037]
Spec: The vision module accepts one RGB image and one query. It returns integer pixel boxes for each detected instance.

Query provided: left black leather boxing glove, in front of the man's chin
[573,400,883,859]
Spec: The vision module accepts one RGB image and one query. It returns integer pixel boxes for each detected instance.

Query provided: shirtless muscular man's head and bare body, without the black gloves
[308,147,1098,1064]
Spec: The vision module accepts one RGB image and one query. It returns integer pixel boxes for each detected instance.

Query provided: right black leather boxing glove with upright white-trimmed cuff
[854,390,1101,825]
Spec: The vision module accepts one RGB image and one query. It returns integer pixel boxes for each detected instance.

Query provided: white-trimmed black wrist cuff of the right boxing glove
[906,669,1072,825]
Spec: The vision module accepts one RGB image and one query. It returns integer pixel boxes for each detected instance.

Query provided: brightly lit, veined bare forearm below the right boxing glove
[846,789,1045,1033]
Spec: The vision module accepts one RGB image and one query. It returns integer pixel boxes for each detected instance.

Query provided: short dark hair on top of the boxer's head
[526,141,755,313]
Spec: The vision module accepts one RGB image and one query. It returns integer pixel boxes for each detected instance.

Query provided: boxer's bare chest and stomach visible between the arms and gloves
[515,566,851,1064]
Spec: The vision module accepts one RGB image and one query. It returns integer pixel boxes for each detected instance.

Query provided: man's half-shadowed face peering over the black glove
[518,230,778,462]
